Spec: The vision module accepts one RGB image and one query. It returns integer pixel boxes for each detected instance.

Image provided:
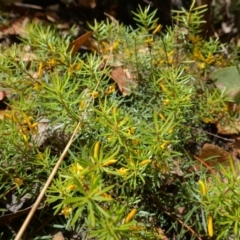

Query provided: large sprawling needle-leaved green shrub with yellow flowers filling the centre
[0,0,237,239]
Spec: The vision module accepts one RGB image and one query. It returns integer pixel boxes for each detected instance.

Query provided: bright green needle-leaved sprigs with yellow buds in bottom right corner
[200,161,240,239]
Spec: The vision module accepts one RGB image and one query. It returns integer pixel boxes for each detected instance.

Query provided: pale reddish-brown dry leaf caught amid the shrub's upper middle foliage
[110,67,136,95]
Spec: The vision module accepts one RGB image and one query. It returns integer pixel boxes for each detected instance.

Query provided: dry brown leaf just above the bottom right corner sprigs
[199,143,231,167]
